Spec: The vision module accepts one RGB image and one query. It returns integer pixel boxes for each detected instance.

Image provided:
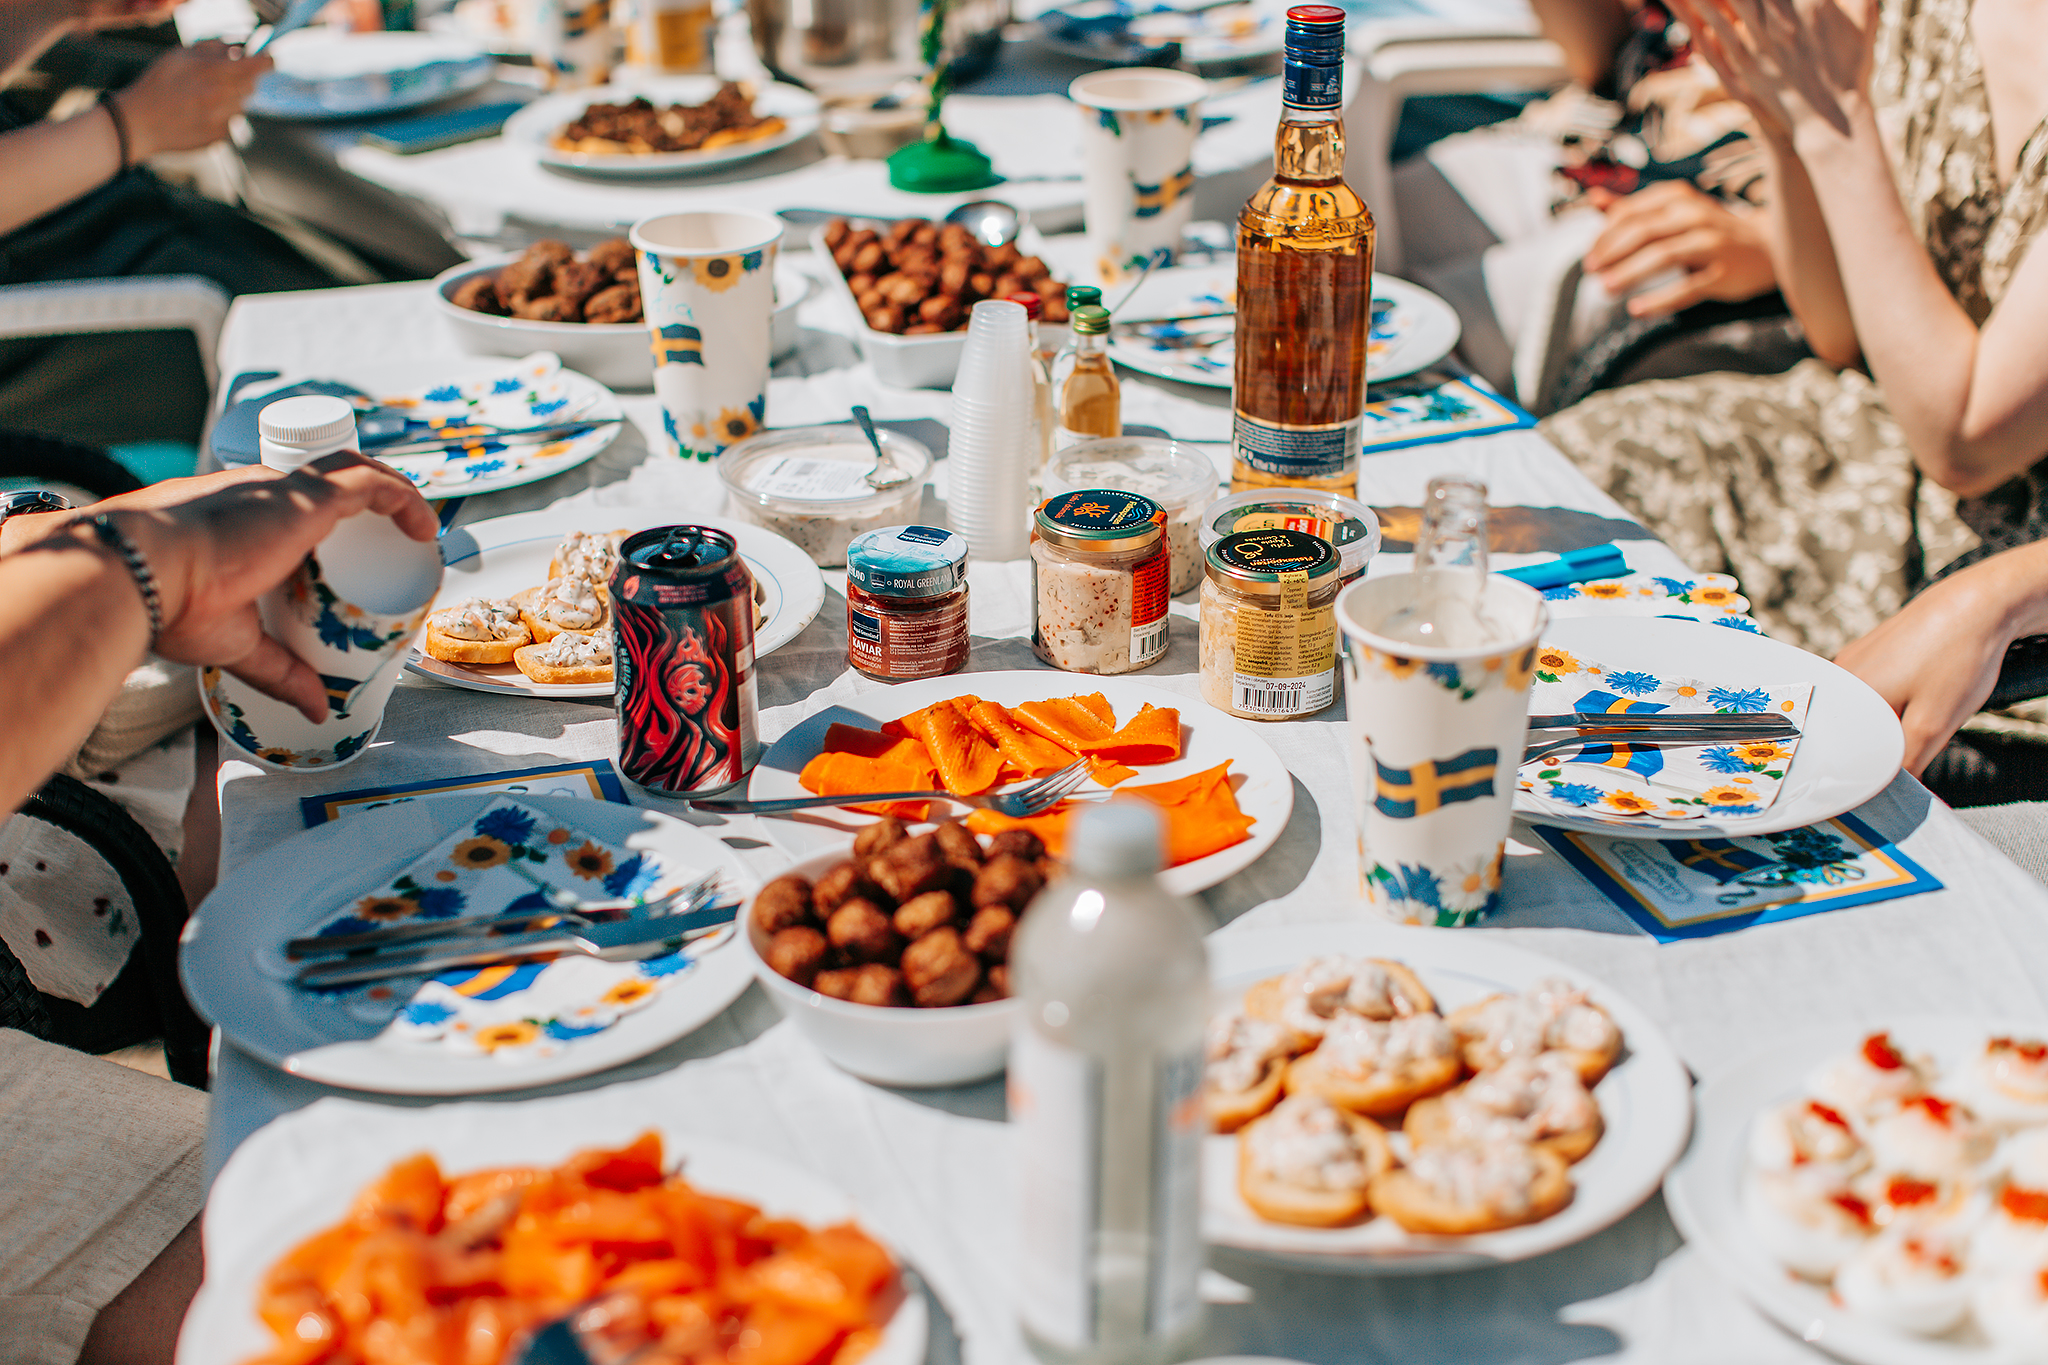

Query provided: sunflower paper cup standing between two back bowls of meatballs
[631,213,782,460]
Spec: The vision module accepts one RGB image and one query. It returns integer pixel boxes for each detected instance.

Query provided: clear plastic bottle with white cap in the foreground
[1010,800,1208,1365]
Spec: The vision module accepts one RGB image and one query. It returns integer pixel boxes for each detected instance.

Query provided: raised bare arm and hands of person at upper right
[1673,0,2048,497]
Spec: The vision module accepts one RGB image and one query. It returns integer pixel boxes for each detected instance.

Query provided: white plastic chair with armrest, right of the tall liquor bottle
[1343,16,1581,405]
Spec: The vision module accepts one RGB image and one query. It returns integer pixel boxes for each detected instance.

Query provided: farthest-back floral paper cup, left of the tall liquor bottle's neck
[1067,68,1208,284]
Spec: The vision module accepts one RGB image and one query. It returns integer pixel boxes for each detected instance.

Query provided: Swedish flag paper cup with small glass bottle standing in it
[1337,573,1548,927]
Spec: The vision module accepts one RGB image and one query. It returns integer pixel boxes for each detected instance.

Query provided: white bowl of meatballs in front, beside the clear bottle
[741,821,1053,1087]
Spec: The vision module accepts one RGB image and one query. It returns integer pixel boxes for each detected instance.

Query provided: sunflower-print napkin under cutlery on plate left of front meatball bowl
[296,798,723,1064]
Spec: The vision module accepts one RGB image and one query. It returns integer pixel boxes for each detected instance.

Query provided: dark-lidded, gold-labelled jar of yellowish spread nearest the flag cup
[1200,530,1341,720]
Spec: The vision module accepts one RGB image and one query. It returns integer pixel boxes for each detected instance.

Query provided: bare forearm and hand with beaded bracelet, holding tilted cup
[0,454,436,810]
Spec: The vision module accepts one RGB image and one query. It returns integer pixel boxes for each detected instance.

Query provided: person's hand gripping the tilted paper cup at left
[117,450,438,722]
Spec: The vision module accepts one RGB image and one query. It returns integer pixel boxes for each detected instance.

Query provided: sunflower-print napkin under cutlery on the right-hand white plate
[1516,645,1812,829]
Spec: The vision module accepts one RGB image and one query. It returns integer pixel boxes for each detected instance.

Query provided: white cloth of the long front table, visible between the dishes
[188,245,2048,1365]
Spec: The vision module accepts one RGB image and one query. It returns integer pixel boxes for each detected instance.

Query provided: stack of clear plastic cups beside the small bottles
[946,299,1036,559]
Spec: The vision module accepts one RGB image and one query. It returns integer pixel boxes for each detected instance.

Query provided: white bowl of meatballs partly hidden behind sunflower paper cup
[434,237,811,389]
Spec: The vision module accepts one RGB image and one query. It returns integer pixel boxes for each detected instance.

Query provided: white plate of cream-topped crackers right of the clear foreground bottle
[1202,923,1692,1275]
